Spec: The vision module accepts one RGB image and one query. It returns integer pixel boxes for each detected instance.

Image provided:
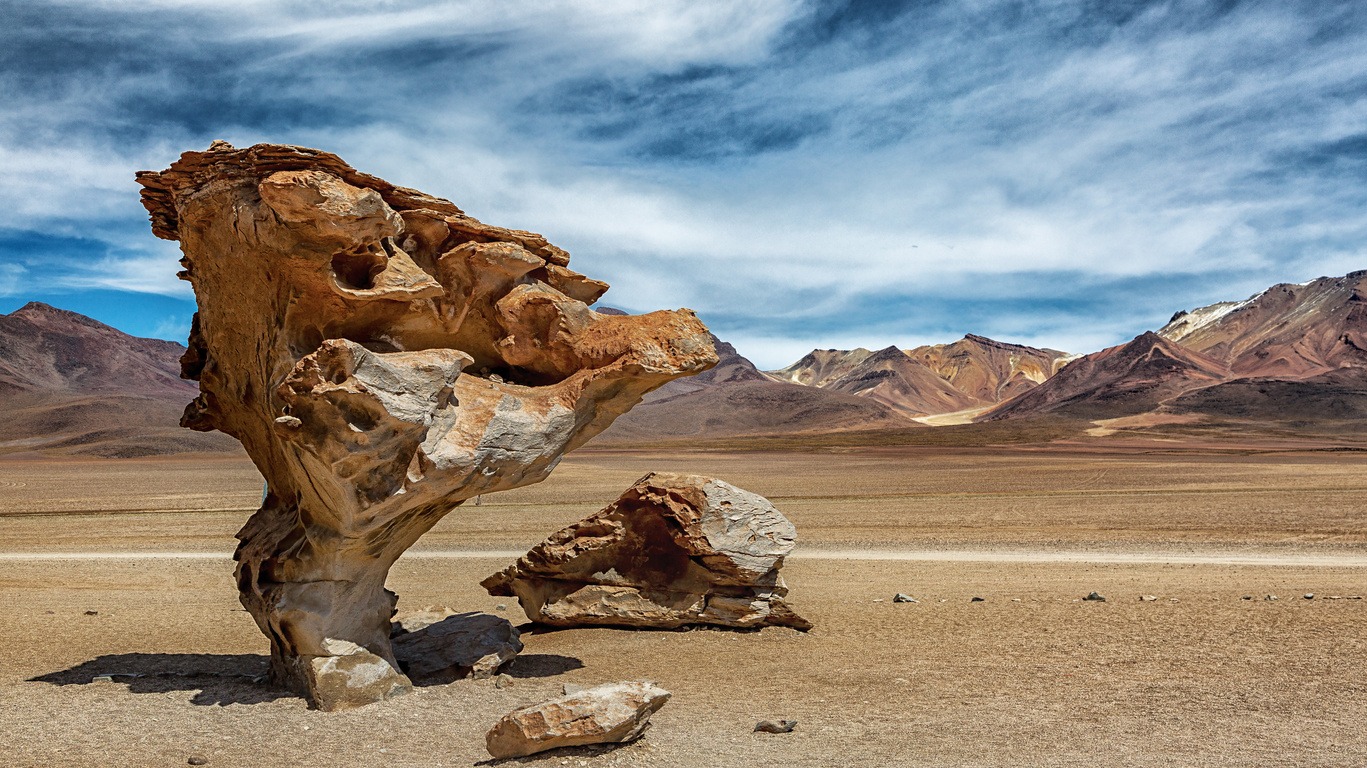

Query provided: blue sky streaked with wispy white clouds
[0,0,1367,368]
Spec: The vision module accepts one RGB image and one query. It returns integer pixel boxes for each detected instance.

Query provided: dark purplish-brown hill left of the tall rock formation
[0,302,241,456]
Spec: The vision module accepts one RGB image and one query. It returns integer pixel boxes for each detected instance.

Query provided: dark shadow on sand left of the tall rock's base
[29,653,284,707]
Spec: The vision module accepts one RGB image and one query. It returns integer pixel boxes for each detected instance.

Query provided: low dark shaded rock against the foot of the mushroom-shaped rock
[390,608,522,683]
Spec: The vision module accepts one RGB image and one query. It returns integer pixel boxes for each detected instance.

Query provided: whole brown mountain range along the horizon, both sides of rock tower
[8,271,1367,456]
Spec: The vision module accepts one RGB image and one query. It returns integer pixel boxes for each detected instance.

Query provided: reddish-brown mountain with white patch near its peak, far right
[979,271,1367,422]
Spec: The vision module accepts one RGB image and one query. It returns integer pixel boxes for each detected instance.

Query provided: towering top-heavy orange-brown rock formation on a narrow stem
[138,142,716,709]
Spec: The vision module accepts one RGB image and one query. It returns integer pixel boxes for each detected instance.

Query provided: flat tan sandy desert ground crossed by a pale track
[0,450,1367,767]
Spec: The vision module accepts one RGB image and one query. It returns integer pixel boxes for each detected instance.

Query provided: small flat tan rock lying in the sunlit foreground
[485,682,670,758]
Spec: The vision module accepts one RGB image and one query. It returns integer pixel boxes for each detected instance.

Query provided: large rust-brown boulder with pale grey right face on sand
[481,473,812,630]
